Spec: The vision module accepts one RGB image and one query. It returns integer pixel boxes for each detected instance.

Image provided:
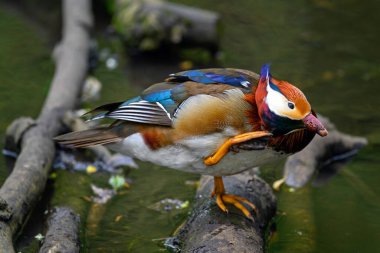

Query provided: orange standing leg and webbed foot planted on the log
[211,177,257,220]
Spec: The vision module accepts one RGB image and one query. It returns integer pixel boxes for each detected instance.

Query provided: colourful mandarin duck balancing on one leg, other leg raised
[55,65,327,219]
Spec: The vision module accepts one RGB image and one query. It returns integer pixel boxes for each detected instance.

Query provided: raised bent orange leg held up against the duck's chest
[203,131,272,166]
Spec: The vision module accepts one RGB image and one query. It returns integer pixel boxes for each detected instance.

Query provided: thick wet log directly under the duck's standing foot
[173,170,276,253]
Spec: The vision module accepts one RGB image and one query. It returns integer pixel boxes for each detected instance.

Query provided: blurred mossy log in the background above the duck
[114,0,221,52]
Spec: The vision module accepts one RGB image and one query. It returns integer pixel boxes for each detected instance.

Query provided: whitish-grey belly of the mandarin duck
[107,133,286,176]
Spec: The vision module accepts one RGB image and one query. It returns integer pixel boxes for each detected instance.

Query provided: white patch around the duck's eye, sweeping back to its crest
[265,78,300,120]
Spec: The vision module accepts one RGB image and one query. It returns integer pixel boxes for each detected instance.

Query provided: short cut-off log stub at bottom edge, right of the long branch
[39,207,80,253]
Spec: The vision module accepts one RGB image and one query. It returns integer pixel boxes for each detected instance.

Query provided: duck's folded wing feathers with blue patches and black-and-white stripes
[85,69,257,126]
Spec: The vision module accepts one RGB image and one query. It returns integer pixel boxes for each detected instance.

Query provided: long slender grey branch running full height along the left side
[0,0,92,253]
